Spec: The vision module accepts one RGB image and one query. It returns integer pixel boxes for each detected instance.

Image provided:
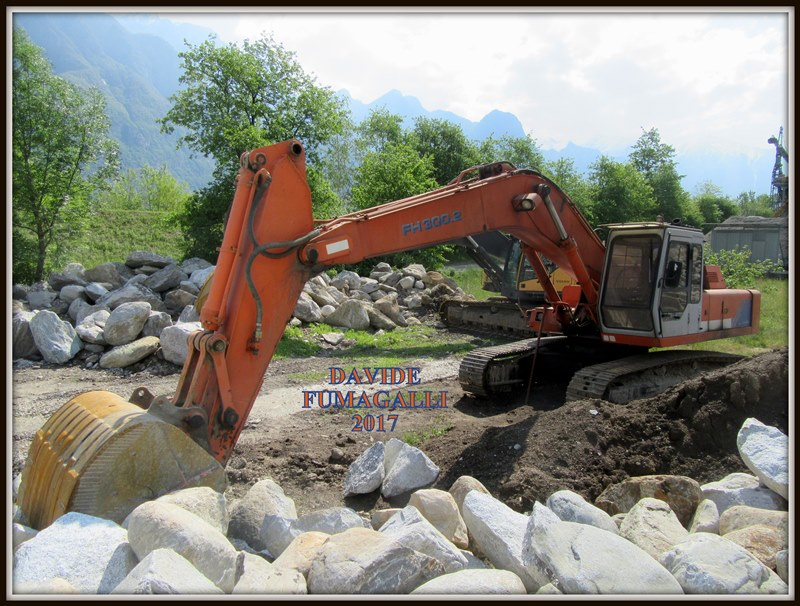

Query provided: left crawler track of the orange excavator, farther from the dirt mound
[458,336,567,398]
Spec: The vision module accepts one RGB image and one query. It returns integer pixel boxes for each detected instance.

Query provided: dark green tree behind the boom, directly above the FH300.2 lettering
[411,117,478,185]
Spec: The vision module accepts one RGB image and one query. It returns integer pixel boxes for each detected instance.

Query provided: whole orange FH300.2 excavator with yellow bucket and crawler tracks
[18,141,761,528]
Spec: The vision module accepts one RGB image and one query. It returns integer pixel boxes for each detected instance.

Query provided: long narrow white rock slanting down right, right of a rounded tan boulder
[461,490,540,592]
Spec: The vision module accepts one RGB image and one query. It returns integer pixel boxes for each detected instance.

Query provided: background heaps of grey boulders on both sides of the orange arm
[12,251,463,368]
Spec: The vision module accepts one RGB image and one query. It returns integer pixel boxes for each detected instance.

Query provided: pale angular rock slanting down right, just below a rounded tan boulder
[380,505,467,572]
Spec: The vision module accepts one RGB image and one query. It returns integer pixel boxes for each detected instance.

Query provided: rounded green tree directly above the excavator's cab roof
[588,156,657,225]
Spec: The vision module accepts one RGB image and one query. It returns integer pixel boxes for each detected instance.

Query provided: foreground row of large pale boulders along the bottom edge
[13,419,789,594]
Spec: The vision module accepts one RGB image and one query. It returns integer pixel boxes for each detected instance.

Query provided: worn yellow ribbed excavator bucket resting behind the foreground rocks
[18,391,227,529]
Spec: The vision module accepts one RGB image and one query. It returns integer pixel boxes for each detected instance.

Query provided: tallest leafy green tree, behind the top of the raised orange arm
[161,34,348,258]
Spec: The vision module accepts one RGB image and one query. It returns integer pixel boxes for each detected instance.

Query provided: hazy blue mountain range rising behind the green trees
[13,13,774,197]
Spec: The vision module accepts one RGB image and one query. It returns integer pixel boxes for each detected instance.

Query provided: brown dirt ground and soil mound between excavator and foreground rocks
[12,331,789,514]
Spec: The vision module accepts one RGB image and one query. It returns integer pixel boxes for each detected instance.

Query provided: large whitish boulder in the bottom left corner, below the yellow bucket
[13,516,137,594]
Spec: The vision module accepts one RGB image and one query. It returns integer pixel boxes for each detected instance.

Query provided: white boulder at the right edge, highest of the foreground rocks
[736,418,789,499]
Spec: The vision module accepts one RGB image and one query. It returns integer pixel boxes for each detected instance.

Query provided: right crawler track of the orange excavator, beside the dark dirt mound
[567,350,742,404]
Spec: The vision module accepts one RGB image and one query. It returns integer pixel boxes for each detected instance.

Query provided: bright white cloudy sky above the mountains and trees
[153,8,794,157]
